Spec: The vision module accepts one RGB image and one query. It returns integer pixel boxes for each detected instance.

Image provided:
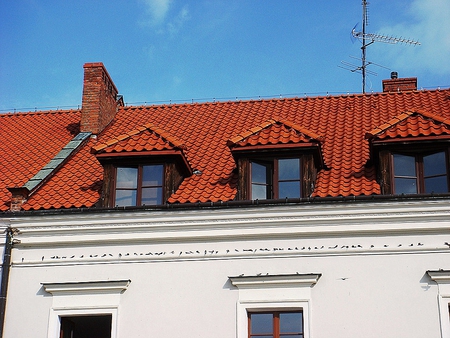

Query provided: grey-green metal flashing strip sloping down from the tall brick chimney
[23,132,91,193]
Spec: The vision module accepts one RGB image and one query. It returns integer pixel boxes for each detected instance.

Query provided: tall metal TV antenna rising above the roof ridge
[341,0,420,93]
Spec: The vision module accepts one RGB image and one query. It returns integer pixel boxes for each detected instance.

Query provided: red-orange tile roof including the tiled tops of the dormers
[0,89,450,211]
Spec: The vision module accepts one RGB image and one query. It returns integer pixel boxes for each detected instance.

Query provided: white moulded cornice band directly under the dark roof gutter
[5,200,450,247]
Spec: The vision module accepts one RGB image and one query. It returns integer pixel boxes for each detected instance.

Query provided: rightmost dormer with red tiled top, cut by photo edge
[366,112,450,195]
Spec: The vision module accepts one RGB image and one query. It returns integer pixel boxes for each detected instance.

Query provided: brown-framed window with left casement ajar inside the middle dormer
[250,158,302,200]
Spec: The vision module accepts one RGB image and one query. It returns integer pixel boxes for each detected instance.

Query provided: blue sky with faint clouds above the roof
[0,0,450,112]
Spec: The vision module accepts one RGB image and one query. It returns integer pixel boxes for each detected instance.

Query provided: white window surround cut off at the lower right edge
[427,270,450,338]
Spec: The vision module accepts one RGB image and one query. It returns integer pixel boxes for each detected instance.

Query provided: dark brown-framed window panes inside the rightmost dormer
[392,151,449,194]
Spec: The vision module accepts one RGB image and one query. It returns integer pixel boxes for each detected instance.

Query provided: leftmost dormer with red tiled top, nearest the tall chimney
[92,123,192,207]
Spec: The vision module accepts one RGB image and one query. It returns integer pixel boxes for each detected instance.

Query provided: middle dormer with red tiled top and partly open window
[228,120,323,200]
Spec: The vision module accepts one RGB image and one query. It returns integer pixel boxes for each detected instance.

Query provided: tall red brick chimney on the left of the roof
[81,62,123,135]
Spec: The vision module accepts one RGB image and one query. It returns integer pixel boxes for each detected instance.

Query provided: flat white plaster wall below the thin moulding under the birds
[5,254,450,338]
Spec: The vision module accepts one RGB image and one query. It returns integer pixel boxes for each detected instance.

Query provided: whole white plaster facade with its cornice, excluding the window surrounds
[5,204,450,338]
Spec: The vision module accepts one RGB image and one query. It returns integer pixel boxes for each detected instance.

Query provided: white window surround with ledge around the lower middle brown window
[229,273,321,338]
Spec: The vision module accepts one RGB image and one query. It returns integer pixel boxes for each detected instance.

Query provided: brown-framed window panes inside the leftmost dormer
[115,164,164,206]
